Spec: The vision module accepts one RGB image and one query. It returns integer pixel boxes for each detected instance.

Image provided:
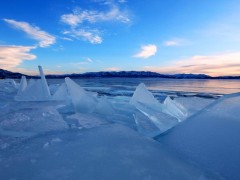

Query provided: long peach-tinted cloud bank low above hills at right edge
[145,52,240,76]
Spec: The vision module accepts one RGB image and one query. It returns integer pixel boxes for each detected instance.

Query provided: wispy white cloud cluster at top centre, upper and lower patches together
[60,0,131,44]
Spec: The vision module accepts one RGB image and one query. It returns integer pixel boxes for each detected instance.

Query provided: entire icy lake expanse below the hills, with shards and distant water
[0,78,240,180]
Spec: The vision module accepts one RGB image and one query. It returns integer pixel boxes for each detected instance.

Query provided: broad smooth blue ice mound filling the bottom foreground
[0,124,220,180]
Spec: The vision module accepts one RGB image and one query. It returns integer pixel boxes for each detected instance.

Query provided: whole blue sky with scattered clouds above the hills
[0,0,240,76]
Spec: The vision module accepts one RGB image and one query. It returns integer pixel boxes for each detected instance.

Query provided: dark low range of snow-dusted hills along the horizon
[0,69,240,79]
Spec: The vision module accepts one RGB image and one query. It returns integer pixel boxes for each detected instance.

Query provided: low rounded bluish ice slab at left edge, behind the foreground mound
[0,106,67,136]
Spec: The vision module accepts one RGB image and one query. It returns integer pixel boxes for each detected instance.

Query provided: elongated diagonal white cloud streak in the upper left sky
[3,19,56,47]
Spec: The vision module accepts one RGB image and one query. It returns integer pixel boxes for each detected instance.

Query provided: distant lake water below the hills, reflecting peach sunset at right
[48,78,240,94]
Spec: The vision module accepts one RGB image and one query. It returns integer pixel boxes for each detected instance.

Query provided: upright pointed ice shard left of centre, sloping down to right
[65,77,97,113]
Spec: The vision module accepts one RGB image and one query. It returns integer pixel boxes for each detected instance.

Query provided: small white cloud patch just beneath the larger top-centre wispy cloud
[63,29,103,44]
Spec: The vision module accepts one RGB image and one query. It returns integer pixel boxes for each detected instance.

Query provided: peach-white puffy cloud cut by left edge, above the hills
[0,46,36,69]
